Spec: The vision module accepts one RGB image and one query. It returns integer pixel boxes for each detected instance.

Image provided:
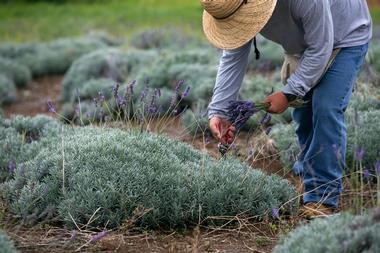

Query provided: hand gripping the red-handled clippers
[210,116,235,144]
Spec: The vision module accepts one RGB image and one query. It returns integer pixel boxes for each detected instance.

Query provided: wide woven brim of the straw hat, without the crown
[203,0,277,49]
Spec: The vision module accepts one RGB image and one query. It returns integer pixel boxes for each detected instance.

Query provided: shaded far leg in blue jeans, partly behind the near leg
[292,91,314,176]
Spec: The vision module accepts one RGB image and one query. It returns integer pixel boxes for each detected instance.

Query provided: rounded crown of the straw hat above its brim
[200,0,246,19]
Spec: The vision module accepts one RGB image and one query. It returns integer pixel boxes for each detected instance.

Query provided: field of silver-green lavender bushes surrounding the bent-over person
[0,11,380,253]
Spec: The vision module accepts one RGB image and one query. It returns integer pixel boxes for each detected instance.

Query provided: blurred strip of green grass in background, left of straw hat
[0,0,202,42]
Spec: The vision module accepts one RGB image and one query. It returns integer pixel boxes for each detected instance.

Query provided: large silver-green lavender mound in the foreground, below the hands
[0,116,296,228]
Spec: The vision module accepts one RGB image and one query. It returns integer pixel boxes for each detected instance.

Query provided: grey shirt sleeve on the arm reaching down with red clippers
[208,41,252,118]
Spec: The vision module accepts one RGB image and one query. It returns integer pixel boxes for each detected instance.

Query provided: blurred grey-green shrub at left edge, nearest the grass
[0,57,32,87]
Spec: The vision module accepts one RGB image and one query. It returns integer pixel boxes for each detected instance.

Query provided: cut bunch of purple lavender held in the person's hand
[218,98,309,157]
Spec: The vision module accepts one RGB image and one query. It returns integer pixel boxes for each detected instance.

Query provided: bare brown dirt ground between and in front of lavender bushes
[0,76,301,253]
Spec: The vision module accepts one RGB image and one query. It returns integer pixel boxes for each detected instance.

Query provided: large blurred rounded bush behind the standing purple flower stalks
[62,49,155,102]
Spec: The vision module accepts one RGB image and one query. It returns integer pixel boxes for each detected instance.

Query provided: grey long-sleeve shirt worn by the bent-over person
[208,0,372,118]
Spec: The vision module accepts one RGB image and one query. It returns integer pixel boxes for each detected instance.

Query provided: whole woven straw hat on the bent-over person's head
[200,0,277,49]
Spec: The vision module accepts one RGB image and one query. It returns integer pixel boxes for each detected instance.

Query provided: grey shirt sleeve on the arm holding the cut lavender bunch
[282,0,334,97]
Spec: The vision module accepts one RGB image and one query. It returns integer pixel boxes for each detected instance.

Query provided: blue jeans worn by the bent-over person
[292,44,368,207]
